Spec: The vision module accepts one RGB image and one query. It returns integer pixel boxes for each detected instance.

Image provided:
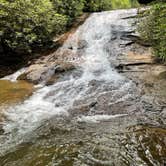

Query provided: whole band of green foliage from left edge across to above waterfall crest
[0,0,140,54]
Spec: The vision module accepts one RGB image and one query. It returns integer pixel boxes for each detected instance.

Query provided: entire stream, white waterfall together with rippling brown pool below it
[0,9,166,166]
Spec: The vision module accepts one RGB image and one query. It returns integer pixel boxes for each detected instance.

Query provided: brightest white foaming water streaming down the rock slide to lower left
[1,10,136,134]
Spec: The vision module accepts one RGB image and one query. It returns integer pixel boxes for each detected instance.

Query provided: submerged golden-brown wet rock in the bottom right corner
[122,125,166,166]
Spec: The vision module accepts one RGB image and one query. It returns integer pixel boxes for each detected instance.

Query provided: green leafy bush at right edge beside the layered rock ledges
[139,2,166,60]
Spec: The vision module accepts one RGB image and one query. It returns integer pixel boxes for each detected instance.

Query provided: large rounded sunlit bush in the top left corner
[0,0,66,53]
